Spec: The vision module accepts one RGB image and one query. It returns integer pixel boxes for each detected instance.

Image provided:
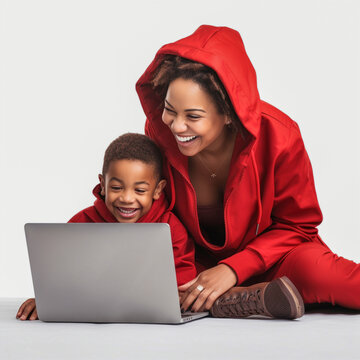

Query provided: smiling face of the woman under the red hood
[162,78,230,156]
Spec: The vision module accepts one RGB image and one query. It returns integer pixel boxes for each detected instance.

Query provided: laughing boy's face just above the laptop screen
[99,159,166,223]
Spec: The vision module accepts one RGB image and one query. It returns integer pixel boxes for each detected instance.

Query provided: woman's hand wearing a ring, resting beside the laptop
[178,264,237,311]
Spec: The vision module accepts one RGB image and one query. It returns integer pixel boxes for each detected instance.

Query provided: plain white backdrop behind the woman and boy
[0,0,360,297]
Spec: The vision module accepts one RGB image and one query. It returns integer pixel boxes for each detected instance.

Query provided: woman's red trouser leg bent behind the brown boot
[261,243,360,310]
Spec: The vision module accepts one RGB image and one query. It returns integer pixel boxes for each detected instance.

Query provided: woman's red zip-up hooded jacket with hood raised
[136,25,325,284]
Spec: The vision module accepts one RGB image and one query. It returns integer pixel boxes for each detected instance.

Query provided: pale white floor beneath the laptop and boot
[0,298,360,360]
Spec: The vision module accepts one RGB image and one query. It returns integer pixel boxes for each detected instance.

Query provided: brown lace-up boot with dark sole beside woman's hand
[210,276,304,319]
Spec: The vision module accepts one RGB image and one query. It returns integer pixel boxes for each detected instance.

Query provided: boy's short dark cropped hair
[102,133,162,180]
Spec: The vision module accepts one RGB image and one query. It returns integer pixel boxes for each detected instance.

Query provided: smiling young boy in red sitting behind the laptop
[16,133,196,320]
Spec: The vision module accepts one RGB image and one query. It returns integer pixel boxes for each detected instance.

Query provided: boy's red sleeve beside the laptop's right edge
[166,212,197,286]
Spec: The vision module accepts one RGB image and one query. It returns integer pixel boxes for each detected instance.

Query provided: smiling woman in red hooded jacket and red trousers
[137,25,360,316]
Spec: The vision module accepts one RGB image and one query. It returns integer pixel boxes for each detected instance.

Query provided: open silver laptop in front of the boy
[25,223,208,324]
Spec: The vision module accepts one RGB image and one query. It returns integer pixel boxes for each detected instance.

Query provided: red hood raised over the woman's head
[136,25,260,153]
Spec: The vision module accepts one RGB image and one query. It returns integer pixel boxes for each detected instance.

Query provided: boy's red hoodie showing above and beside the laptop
[69,184,196,285]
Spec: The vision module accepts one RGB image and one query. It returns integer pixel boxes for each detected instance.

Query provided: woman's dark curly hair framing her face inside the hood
[152,55,244,134]
